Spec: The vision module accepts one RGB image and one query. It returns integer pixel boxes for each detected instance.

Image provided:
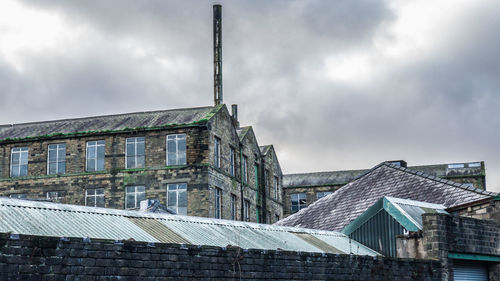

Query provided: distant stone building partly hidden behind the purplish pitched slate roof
[283,160,486,217]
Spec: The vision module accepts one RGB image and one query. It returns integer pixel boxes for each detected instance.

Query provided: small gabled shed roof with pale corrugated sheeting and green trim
[342,196,448,235]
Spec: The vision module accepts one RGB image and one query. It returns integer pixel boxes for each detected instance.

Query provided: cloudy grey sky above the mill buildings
[0,0,500,191]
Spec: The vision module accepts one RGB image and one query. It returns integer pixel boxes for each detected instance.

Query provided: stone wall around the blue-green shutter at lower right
[396,214,500,281]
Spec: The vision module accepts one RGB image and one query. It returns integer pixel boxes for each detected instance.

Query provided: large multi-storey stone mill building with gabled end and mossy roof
[0,104,283,223]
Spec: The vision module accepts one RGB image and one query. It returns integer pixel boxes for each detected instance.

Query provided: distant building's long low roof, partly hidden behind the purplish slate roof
[283,162,485,188]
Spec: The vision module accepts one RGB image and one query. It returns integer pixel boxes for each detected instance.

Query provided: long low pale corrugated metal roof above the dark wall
[0,197,377,256]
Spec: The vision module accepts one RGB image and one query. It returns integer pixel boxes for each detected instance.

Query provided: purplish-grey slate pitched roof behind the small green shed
[276,162,496,231]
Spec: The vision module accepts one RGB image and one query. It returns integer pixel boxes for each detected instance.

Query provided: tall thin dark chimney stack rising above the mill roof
[214,5,223,105]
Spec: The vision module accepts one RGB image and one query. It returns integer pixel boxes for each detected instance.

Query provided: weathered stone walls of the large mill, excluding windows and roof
[0,105,282,222]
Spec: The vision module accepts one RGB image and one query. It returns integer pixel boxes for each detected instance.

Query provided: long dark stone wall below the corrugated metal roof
[0,234,441,281]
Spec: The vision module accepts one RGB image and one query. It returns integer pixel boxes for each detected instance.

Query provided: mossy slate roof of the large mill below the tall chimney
[0,106,221,140]
